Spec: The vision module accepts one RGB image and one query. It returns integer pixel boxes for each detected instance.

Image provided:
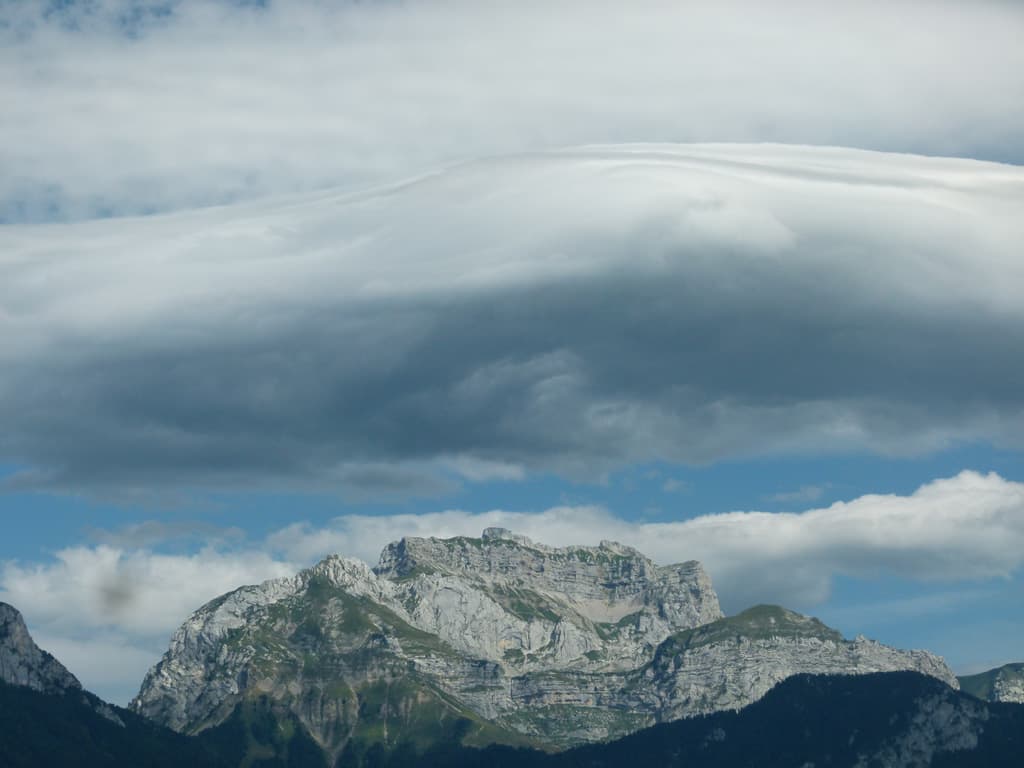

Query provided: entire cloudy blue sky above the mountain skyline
[0,0,1024,703]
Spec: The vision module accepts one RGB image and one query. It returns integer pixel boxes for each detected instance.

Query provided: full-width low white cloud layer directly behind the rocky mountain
[0,472,1024,700]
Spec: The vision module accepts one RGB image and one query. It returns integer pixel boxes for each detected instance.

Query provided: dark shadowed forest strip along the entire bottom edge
[0,672,1024,768]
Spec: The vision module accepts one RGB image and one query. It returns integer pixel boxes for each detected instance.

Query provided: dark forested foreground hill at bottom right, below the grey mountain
[393,672,1024,768]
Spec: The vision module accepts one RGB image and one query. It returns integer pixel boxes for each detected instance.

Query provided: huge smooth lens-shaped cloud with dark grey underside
[0,146,1024,494]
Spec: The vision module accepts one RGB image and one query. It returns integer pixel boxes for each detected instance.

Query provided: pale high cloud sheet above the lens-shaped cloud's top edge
[0,0,1024,221]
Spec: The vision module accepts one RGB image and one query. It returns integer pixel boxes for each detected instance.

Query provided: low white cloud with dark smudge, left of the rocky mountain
[0,540,300,705]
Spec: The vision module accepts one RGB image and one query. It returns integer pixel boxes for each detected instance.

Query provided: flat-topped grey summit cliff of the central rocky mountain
[374,528,722,673]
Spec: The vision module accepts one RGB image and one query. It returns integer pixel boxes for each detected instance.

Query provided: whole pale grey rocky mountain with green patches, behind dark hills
[133,528,956,755]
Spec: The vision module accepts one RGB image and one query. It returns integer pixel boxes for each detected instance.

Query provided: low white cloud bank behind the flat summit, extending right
[268,471,1024,610]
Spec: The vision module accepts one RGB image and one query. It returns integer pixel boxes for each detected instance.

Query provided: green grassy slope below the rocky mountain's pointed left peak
[203,578,527,765]
